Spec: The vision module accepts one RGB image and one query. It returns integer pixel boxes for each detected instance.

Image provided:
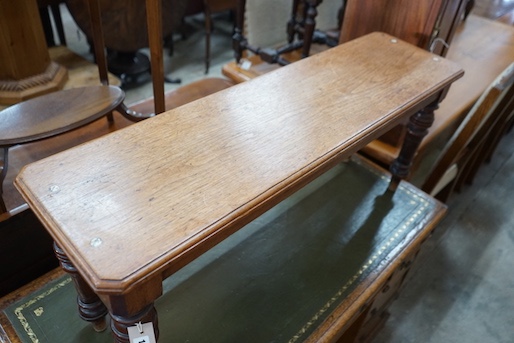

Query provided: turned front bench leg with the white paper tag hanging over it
[111,303,159,343]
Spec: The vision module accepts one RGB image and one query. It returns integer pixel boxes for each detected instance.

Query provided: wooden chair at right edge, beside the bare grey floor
[422,63,514,201]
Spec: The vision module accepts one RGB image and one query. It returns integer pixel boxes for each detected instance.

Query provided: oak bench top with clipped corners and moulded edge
[16,33,462,293]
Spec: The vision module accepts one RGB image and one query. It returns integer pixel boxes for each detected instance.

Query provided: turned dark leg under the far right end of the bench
[389,101,439,191]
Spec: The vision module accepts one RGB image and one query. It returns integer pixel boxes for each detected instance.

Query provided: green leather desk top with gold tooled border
[6,161,444,343]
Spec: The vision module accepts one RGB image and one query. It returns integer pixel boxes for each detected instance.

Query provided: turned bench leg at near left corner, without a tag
[54,243,107,332]
